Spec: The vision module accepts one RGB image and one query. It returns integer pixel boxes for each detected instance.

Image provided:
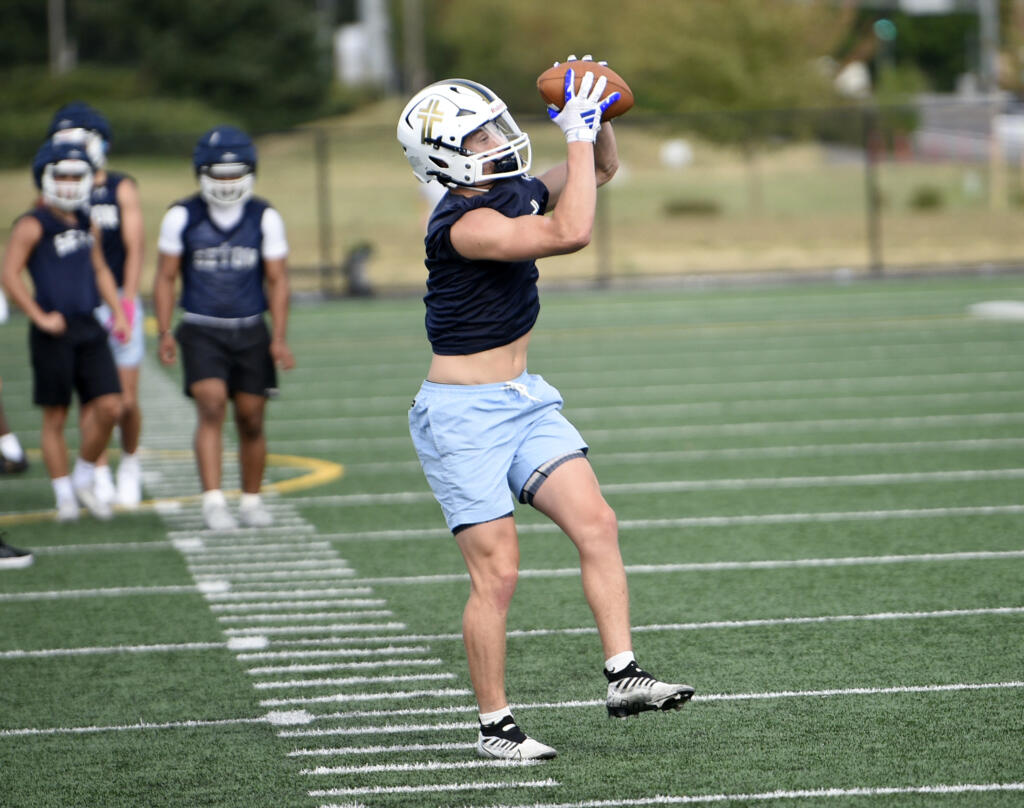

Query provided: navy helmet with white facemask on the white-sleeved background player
[193,126,256,208]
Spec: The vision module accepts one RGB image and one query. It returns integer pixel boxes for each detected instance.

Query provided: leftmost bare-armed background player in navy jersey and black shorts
[2,140,128,520]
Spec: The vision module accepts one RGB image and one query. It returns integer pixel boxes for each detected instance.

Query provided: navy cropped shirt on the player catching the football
[423,176,548,355]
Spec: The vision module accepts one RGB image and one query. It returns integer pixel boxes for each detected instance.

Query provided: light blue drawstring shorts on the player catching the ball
[409,373,587,530]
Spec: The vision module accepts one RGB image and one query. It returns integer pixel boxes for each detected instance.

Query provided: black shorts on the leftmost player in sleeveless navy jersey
[29,312,121,407]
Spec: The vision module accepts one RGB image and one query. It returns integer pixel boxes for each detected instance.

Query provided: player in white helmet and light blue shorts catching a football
[398,57,693,759]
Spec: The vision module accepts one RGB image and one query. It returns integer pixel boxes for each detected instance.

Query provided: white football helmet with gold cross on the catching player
[398,79,530,187]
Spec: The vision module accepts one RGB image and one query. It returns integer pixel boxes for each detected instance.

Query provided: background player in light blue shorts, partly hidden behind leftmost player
[47,101,145,508]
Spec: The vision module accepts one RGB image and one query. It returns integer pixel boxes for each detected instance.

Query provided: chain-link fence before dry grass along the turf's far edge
[0,99,1024,295]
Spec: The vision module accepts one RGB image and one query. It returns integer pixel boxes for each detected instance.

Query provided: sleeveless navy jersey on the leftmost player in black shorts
[25,206,99,316]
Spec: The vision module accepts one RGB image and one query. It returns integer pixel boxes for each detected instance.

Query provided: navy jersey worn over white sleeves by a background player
[175,194,269,317]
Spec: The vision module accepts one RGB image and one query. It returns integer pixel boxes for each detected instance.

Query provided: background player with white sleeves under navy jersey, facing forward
[153,126,295,530]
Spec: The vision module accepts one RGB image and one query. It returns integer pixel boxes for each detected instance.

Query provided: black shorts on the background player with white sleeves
[174,322,278,396]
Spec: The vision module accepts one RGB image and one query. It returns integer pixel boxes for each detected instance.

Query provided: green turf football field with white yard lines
[0,277,1024,808]
